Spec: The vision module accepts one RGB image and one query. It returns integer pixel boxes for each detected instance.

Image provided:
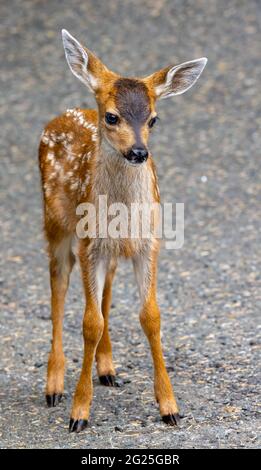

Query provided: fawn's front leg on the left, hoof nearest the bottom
[69,248,107,432]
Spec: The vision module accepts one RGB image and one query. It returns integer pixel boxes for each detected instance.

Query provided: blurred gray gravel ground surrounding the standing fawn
[0,0,261,449]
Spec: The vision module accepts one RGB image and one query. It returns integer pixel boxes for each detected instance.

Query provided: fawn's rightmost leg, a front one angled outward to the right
[133,251,179,425]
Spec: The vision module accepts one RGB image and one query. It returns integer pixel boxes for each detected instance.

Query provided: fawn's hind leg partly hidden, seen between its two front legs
[96,259,117,387]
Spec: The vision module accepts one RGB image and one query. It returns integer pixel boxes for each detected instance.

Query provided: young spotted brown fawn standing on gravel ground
[39,29,207,433]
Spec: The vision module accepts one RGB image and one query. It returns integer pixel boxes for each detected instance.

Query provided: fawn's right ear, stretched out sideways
[146,57,208,99]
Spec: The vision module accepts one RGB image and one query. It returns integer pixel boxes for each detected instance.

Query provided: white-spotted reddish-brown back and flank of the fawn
[39,108,98,232]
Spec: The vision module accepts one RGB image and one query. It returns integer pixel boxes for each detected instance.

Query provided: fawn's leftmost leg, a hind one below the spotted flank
[46,232,75,407]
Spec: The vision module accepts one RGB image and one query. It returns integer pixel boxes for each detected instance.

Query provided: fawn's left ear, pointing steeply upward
[62,29,107,93]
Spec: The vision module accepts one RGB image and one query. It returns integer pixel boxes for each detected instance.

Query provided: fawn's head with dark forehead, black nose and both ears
[62,30,207,165]
